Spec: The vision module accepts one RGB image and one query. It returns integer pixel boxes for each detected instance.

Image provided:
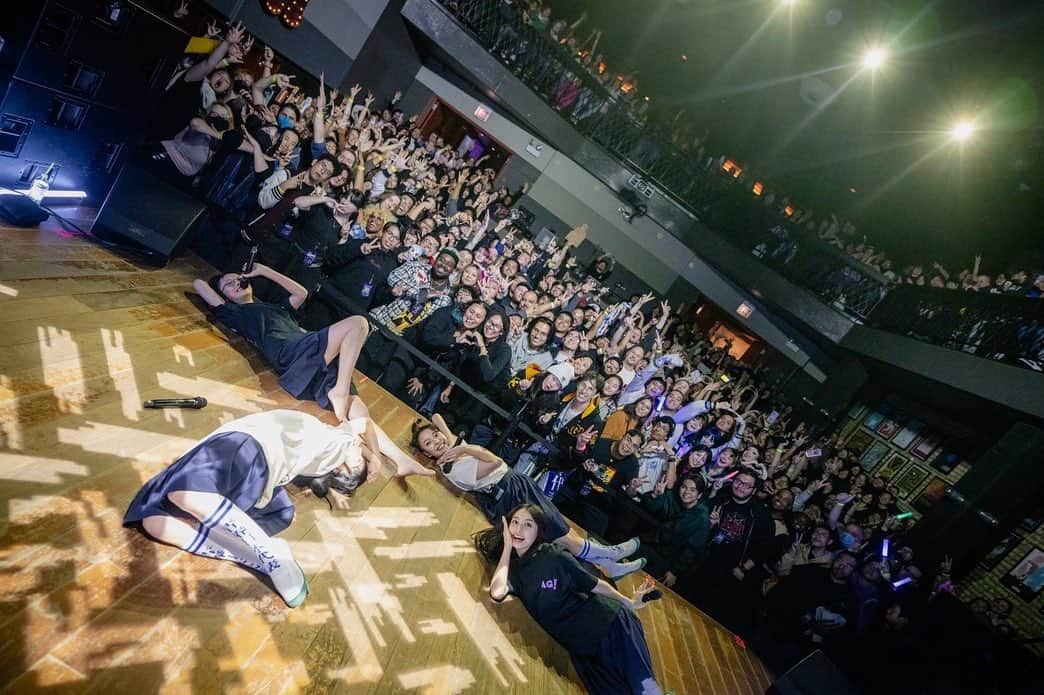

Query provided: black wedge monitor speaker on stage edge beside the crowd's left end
[91,162,206,263]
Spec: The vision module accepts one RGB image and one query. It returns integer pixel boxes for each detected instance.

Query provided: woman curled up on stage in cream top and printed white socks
[123,410,430,608]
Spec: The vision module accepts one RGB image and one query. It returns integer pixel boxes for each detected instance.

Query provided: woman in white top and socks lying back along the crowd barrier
[412,413,645,579]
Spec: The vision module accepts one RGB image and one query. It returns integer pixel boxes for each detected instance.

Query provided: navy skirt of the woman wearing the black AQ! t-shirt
[569,609,660,695]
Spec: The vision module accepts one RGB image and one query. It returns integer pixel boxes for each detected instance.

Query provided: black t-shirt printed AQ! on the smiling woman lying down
[507,544,627,655]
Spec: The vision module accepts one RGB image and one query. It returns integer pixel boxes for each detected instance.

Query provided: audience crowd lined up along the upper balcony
[445,0,1044,308]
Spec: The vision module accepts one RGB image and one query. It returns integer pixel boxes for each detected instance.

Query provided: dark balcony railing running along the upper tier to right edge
[435,0,1044,368]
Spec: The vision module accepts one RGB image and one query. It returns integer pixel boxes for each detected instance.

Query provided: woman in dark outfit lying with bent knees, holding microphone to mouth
[192,263,370,421]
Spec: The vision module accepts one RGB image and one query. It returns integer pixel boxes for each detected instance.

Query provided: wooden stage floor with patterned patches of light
[0,219,769,695]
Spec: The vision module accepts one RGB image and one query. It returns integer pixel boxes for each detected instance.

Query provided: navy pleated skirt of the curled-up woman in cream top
[123,432,294,535]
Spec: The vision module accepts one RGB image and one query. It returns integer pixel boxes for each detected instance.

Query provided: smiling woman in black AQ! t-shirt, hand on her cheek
[475,504,661,695]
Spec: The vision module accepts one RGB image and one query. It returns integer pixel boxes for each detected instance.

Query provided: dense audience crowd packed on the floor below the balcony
[143,14,1002,677]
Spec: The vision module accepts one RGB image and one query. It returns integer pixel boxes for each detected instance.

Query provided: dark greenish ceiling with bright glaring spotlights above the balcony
[549,0,1044,266]
